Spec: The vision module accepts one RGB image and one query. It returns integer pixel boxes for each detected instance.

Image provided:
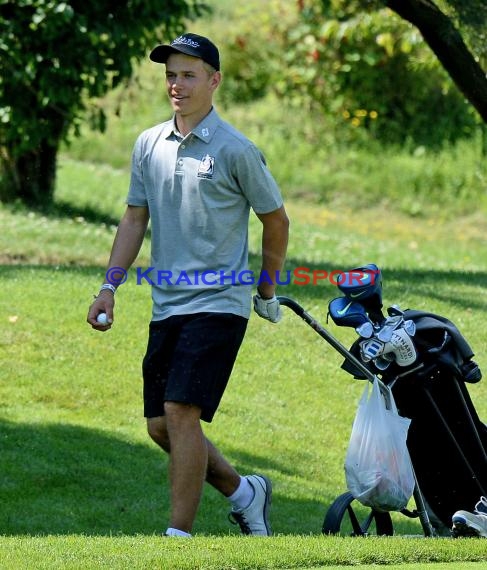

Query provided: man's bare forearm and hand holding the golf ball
[86,206,149,331]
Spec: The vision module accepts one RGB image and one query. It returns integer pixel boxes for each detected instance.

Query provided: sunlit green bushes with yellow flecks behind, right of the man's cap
[215,0,487,148]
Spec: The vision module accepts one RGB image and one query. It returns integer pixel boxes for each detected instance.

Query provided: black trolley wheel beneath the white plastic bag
[322,492,394,536]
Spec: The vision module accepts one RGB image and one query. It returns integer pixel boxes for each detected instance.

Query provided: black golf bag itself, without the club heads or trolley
[342,310,487,528]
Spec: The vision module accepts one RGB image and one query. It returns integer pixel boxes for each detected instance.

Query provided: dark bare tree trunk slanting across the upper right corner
[384,0,487,123]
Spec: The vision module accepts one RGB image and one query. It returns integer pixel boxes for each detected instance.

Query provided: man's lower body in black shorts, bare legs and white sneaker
[144,313,272,535]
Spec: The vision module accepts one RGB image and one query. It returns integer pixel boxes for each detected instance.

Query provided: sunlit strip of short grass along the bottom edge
[0,536,485,570]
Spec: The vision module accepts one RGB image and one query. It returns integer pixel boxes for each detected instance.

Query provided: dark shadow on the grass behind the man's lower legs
[0,420,336,536]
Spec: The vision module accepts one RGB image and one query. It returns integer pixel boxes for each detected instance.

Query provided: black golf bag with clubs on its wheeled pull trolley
[279,264,487,536]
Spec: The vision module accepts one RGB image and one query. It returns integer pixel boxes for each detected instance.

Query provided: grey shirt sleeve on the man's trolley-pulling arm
[235,144,283,214]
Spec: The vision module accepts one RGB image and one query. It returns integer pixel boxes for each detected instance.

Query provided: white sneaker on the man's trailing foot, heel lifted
[229,475,272,536]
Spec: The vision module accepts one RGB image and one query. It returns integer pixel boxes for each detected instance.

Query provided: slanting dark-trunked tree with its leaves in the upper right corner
[384,0,487,123]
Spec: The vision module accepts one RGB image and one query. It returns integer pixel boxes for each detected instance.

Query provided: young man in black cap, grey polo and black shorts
[87,33,289,536]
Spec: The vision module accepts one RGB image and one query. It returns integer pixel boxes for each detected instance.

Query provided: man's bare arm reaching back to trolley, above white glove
[257,206,289,299]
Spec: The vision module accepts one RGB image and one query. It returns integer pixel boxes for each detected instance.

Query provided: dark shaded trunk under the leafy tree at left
[0,141,58,208]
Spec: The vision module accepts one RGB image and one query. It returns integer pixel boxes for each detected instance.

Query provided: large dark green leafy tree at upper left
[0,0,206,207]
